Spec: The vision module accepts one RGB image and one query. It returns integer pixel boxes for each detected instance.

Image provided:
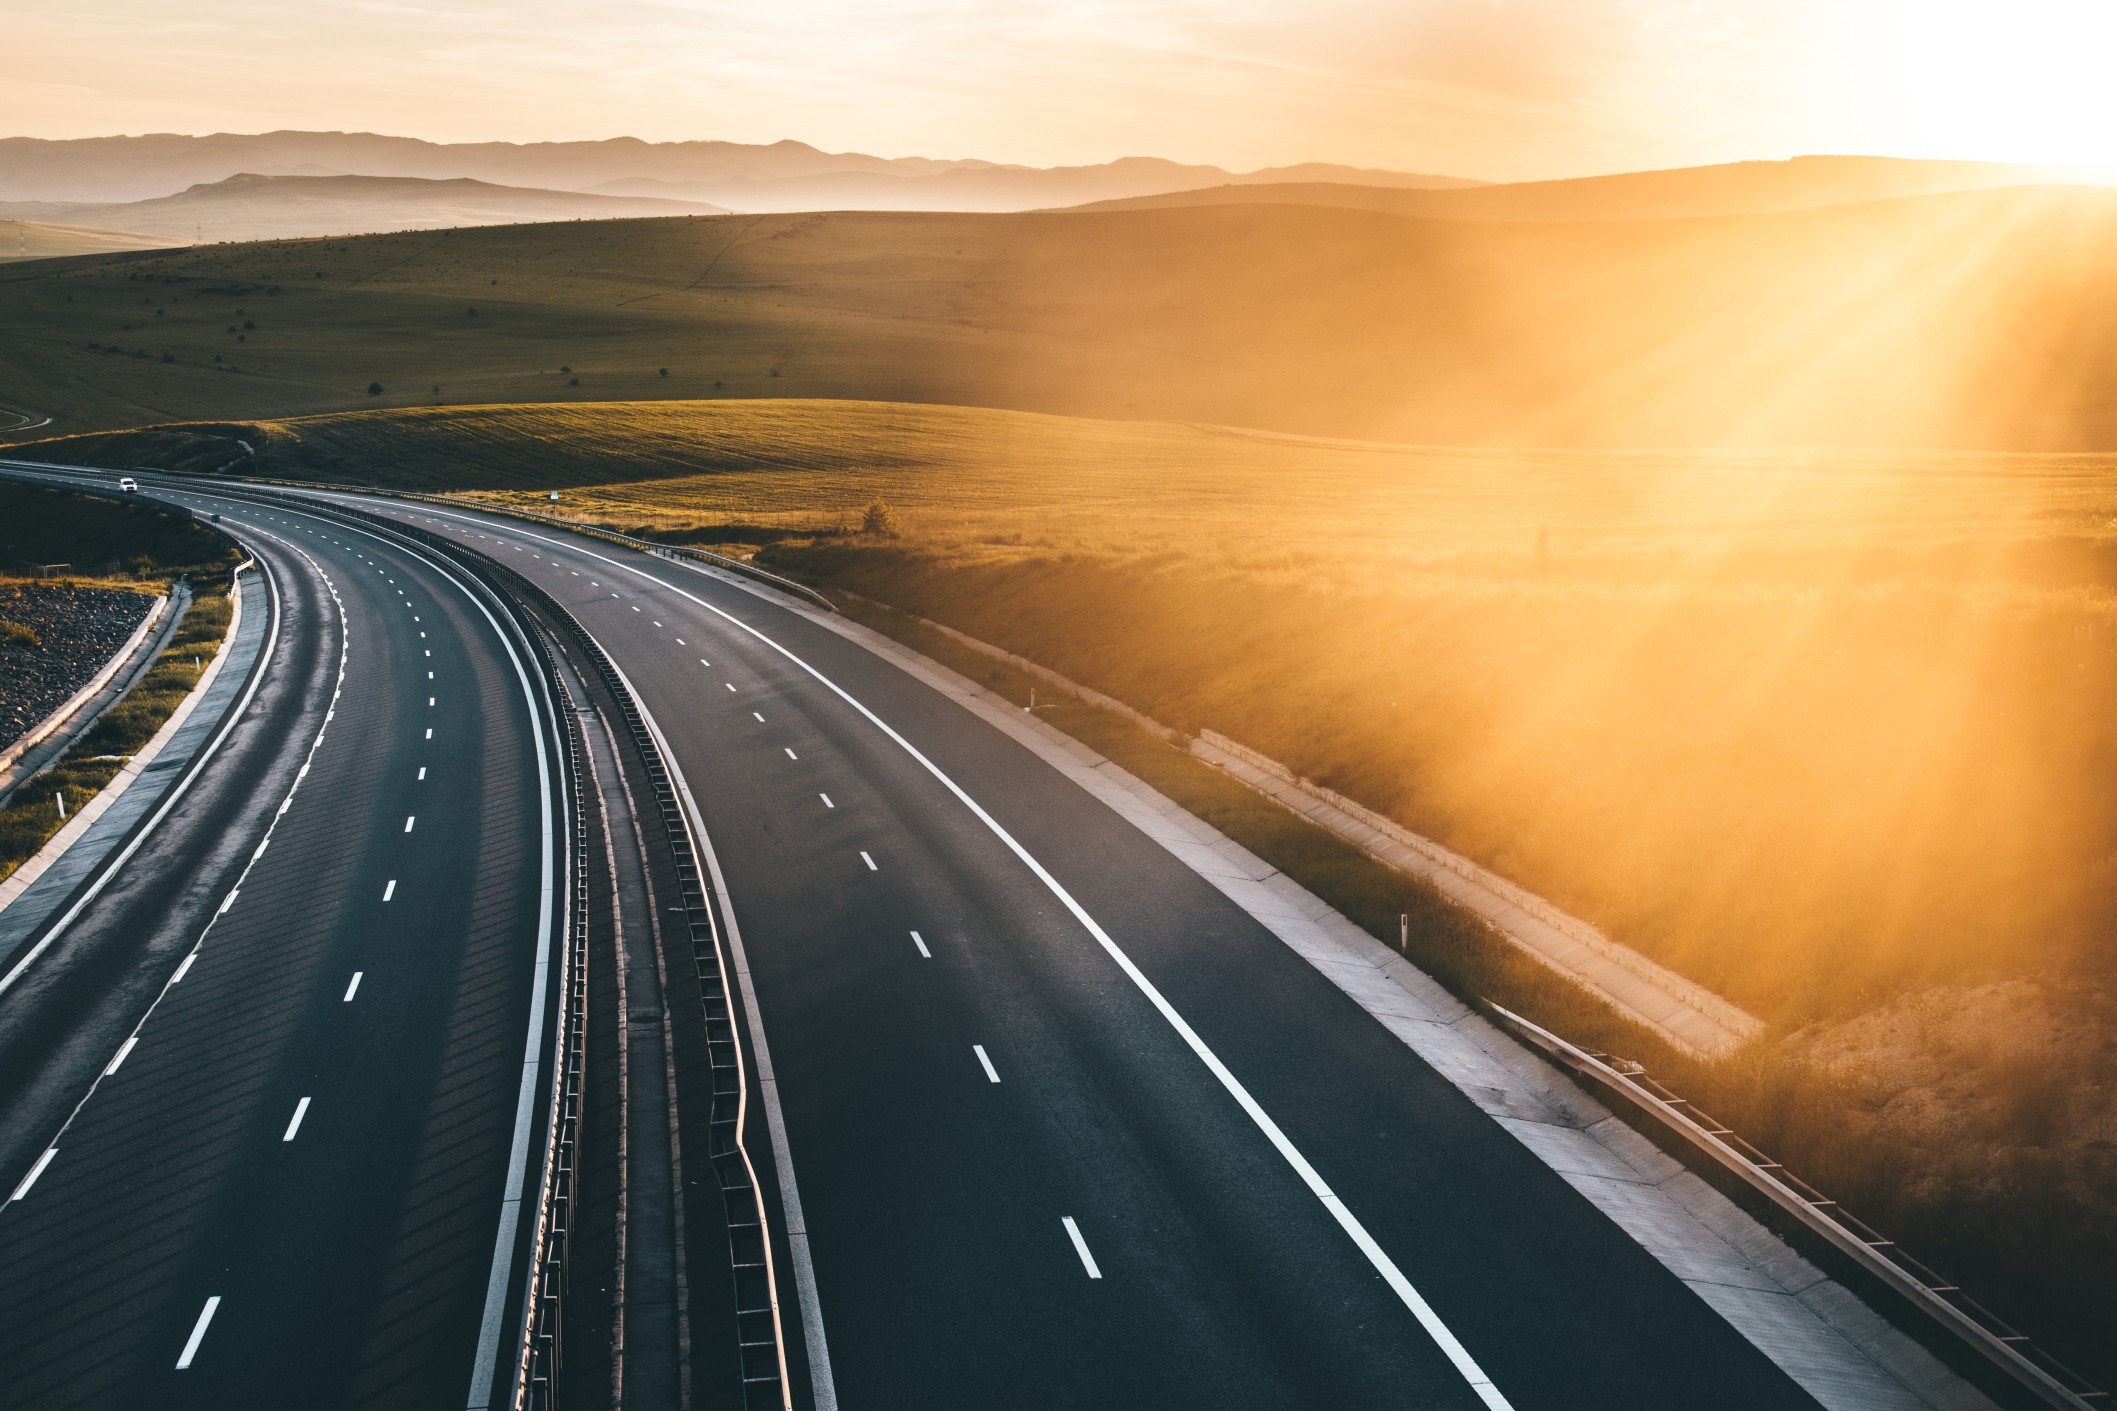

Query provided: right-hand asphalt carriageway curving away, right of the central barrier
[290,497,1814,1411]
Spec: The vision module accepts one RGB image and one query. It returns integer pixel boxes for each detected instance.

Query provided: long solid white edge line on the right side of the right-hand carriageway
[376,501,1512,1411]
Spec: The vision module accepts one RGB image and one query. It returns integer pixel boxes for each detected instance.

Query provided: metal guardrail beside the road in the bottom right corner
[1484,1001,2111,1411]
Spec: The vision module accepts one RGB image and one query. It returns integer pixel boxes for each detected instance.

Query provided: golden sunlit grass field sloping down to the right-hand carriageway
[20,402,2117,1377]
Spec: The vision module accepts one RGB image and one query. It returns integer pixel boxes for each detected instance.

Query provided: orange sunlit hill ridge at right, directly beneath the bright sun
[1082,157,2117,220]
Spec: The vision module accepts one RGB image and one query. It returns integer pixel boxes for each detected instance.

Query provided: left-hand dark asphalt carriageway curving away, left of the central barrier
[0,480,557,1409]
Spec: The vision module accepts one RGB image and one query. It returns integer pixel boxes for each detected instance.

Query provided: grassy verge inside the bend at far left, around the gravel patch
[0,484,237,878]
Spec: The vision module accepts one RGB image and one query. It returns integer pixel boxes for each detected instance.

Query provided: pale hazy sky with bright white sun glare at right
[16,0,2117,178]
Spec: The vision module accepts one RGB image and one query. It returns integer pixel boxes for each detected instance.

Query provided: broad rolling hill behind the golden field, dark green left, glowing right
[0,186,2117,451]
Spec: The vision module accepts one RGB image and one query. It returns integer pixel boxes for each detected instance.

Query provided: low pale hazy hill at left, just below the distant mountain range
[0,171,724,245]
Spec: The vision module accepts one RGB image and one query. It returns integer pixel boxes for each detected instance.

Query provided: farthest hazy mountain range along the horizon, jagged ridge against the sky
[0,131,1476,212]
